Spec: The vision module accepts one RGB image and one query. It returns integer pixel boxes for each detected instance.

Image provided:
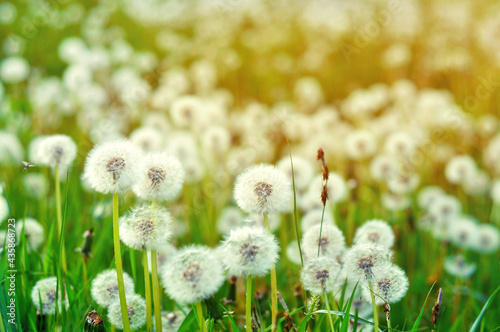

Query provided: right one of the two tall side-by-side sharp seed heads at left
[134,153,184,201]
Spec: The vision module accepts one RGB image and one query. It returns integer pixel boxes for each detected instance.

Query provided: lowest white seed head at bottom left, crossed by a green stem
[108,294,146,329]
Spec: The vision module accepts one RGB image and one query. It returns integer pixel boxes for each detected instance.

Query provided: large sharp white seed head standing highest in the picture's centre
[234,164,292,214]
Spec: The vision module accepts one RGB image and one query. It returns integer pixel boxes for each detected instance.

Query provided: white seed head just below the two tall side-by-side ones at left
[120,205,172,250]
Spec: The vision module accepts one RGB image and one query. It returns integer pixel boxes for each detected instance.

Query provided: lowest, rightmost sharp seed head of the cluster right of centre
[361,264,409,305]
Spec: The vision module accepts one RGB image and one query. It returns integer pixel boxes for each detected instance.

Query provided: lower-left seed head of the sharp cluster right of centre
[300,256,340,294]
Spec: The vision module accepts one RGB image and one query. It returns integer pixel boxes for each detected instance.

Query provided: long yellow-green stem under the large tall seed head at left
[113,194,130,332]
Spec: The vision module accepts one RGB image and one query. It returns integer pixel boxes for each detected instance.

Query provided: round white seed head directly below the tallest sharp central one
[220,226,280,277]
